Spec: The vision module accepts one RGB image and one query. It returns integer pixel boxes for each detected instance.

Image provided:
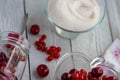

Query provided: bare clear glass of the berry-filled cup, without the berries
[53,52,118,80]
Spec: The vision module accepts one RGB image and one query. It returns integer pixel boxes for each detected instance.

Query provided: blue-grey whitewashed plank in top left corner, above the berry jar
[0,0,24,33]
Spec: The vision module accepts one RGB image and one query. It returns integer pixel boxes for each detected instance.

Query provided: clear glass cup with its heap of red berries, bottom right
[54,52,118,80]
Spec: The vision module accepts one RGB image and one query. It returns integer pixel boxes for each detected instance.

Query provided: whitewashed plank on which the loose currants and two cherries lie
[27,0,70,80]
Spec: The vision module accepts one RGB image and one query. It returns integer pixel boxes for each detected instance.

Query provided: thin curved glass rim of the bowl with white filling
[43,0,106,33]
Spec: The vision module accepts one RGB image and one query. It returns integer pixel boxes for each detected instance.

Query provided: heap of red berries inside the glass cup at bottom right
[61,67,117,80]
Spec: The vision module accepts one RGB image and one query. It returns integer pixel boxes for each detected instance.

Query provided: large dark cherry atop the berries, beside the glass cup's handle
[91,67,103,78]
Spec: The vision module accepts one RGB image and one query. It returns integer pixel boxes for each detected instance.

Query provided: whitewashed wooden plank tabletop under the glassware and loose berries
[0,0,120,80]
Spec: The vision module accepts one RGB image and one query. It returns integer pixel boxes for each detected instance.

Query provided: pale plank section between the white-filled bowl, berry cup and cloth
[72,1,112,59]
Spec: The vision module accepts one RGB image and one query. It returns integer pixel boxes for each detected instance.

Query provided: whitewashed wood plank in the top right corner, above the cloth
[105,0,120,40]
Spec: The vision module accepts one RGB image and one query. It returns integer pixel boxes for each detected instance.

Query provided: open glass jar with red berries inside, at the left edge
[0,32,30,80]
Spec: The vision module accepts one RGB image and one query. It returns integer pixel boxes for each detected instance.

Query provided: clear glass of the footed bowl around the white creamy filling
[42,0,105,38]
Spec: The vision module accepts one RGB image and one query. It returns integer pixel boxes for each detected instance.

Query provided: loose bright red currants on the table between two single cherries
[35,35,61,61]
